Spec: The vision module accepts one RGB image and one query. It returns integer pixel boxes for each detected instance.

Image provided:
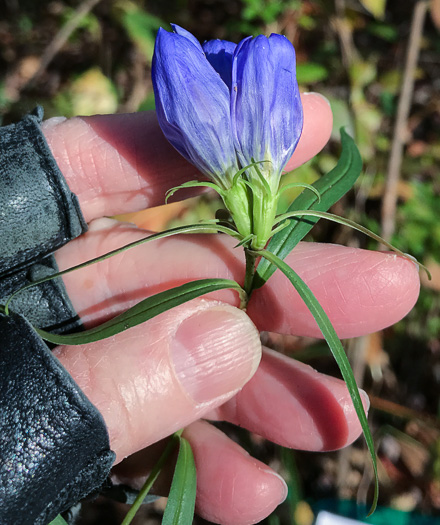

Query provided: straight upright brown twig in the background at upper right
[382,0,428,241]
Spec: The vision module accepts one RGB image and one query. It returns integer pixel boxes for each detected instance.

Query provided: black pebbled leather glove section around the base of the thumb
[0,314,115,525]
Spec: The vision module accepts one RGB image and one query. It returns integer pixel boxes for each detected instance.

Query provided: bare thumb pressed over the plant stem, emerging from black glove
[54,300,261,462]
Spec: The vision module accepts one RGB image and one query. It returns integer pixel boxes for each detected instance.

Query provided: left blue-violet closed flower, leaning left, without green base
[152,29,238,187]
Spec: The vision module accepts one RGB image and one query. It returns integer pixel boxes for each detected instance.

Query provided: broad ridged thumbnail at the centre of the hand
[171,305,261,404]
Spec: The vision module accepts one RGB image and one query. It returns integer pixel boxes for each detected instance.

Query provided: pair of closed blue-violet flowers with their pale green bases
[152,25,303,249]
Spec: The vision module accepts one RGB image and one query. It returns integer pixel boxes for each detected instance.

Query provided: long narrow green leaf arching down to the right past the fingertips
[257,250,379,515]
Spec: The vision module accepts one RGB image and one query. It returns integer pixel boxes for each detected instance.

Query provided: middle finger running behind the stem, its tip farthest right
[57,220,419,338]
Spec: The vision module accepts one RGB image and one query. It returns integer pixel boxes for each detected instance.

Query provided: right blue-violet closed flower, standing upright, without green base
[231,34,303,189]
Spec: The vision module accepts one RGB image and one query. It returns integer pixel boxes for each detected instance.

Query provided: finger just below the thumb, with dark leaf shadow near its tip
[207,349,369,451]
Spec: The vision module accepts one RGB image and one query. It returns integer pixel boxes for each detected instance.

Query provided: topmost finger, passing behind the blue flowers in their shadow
[43,94,332,222]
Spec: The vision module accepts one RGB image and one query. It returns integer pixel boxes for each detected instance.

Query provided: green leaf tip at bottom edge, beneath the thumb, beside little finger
[162,437,197,525]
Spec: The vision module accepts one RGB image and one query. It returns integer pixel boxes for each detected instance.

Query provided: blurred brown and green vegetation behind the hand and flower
[0,0,440,525]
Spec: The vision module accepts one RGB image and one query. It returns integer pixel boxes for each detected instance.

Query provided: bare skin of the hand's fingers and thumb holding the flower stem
[43,94,419,524]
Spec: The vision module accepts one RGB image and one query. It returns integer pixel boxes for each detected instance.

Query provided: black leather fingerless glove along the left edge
[0,108,114,525]
